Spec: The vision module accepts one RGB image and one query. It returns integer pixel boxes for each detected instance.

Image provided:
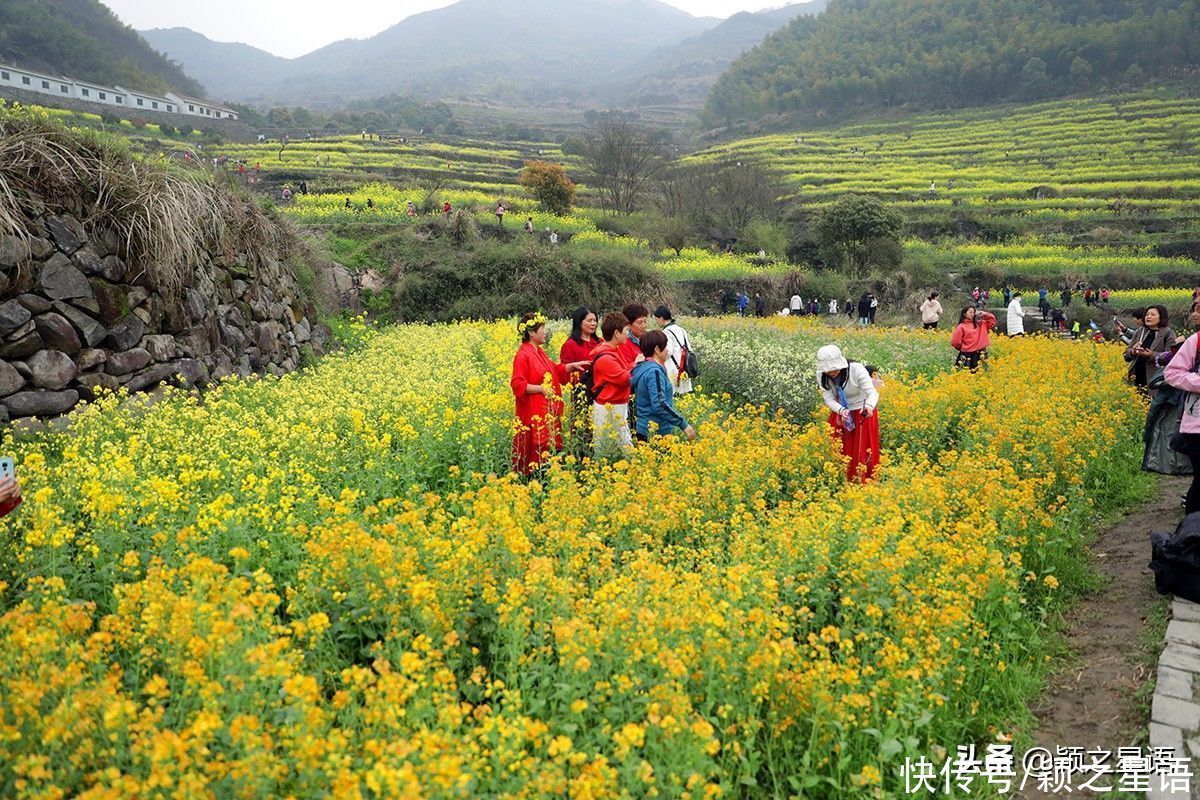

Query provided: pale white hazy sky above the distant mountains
[103,0,794,58]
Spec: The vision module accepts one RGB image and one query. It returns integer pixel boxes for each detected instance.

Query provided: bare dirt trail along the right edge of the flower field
[1016,477,1190,800]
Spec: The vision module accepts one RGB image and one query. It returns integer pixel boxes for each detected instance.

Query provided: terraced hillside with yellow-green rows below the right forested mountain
[690,95,1200,255]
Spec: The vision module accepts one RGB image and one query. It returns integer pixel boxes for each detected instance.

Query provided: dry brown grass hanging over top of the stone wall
[0,103,302,300]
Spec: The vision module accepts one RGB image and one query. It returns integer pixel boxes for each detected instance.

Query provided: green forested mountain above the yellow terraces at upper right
[704,0,1200,126]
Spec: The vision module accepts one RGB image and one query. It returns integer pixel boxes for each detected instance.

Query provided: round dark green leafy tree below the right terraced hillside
[812,196,904,278]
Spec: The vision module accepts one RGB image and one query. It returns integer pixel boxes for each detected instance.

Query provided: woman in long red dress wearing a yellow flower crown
[509,314,588,475]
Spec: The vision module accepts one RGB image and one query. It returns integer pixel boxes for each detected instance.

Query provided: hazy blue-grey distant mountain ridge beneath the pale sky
[144,0,720,107]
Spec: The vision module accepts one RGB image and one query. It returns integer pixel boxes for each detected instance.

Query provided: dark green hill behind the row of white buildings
[0,0,204,97]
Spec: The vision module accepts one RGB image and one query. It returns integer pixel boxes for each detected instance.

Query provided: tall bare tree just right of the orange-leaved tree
[587,119,665,213]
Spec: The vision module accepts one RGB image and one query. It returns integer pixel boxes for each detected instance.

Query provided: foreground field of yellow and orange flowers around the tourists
[0,321,1141,799]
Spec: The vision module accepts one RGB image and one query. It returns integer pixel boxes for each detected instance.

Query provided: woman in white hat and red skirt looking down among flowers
[817,344,880,483]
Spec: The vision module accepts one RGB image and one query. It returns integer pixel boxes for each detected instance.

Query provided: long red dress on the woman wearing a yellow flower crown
[510,342,566,475]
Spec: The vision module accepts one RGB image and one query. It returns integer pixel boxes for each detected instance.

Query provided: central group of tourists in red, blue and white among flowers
[510,303,696,475]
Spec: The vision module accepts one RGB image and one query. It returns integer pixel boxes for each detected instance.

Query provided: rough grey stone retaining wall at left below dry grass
[0,213,325,422]
